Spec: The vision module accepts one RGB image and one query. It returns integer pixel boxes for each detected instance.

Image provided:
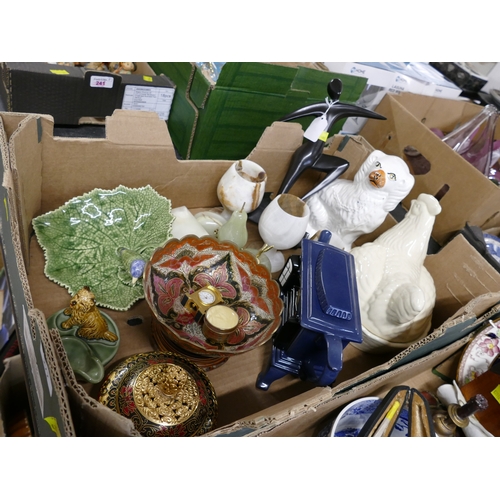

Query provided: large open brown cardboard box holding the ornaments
[0,110,500,436]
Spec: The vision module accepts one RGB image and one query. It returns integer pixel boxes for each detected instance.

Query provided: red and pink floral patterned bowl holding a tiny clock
[143,235,283,357]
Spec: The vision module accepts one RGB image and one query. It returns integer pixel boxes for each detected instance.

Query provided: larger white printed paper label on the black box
[122,85,175,120]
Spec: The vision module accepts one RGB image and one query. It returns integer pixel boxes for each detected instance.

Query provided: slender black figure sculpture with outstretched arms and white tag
[248,78,386,223]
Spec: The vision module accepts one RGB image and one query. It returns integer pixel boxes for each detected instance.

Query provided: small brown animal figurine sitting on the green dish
[61,286,118,342]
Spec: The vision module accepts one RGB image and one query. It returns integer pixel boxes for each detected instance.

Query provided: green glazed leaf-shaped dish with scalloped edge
[33,186,174,311]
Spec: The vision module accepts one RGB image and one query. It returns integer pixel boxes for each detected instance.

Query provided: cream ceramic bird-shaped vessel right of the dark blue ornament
[351,194,441,350]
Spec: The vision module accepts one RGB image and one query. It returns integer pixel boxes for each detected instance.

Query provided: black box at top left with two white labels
[0,62,175,125]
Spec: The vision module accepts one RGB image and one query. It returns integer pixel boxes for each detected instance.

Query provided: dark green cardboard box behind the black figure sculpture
[148,62,366,160]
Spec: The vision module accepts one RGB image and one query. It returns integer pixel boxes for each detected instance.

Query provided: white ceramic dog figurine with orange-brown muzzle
[307,150,415,251]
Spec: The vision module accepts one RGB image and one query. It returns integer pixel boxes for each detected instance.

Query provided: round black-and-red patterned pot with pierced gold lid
[99,352,218,437]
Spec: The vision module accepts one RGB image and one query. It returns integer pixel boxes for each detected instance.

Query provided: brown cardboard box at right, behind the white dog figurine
[360,93,500,245]
